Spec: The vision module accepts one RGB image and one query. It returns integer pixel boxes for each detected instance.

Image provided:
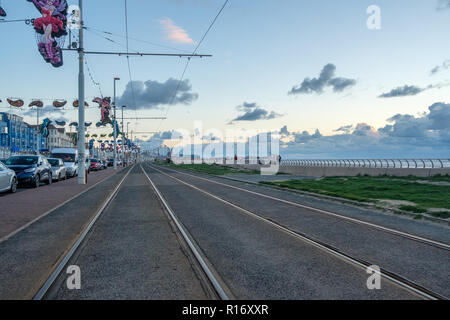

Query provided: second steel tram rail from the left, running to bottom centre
[140,165,230,300]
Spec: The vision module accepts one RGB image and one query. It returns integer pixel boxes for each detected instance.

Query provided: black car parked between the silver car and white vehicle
[5,155,52,188]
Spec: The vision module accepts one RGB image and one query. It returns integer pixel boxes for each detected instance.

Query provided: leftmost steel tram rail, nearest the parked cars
[33,165,134,300]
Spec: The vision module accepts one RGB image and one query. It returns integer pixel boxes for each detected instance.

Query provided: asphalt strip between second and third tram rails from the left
[142,162,428,299]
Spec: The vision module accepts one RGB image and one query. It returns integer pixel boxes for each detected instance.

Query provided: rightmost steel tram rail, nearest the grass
[152,164,450,251]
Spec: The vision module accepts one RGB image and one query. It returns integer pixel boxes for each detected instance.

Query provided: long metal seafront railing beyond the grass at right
[281,159,450,169]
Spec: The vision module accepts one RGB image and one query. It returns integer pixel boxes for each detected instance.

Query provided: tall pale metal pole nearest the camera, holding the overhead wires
[78,0,86,184]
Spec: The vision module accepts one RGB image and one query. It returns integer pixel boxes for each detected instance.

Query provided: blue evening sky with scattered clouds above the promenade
[0,0,450,158]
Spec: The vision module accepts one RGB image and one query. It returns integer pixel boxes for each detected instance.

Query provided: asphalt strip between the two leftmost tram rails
[49,166,210,300]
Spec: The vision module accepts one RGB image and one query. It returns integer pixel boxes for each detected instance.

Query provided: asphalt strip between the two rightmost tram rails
[147,166,450,297]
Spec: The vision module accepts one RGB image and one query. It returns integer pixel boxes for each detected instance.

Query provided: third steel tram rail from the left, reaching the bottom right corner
[149,165,447,300]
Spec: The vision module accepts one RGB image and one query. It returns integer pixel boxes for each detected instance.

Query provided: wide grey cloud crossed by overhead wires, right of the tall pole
[118,78,198,109]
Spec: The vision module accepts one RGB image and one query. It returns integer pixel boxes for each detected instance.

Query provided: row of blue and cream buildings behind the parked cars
[0,112,75,158]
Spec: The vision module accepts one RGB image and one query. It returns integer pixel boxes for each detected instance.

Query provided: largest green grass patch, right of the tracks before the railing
[265,176,450,212]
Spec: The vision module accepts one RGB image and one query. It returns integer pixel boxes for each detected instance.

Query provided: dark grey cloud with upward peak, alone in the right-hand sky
[288,63,356,95]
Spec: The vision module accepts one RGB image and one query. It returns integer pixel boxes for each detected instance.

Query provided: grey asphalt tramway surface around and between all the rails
[0,164,450,300]
